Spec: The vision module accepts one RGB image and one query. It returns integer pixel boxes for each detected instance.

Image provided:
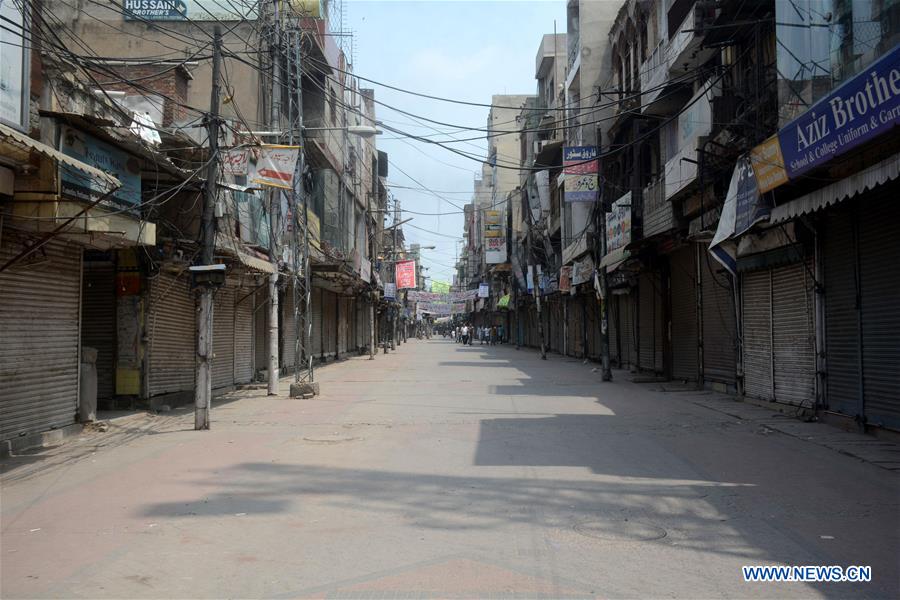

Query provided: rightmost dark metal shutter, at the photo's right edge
[859,196,900,428]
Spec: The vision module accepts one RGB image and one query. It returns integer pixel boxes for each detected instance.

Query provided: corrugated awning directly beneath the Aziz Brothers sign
[769,152,900,223]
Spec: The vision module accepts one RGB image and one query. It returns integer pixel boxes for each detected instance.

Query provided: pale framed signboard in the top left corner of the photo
[0,0,30,131]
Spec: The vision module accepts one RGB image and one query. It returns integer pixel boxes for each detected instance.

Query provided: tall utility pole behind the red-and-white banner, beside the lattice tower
[267,0,281,396]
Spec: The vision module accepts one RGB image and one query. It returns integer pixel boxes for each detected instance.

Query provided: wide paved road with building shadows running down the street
[0,339,900,598]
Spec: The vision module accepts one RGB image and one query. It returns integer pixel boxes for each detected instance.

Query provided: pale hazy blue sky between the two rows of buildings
[344,0,566,281]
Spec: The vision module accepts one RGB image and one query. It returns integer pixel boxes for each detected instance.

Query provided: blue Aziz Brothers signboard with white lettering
[778,44,900,179]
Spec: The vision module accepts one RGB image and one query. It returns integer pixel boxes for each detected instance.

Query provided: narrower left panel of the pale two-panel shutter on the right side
[741,270,774,400]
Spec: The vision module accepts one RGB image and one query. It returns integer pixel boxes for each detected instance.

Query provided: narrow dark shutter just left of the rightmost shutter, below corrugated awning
[822,206,861,416]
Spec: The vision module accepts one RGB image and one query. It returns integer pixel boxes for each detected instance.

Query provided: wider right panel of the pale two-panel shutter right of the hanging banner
[771,263,816,407]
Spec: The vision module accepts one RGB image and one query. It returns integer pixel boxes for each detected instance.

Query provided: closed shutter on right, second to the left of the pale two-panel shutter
[671,244,699,381]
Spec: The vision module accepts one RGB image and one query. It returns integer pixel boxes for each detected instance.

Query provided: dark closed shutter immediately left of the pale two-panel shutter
[700,249,737,385]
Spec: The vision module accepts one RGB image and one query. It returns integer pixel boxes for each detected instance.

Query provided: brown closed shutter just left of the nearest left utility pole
[147,271,195,396]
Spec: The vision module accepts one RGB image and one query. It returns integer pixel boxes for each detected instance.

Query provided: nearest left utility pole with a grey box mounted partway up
[192,25,222,430]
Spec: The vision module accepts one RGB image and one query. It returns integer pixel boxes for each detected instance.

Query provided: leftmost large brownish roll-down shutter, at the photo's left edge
[0,239,82,440]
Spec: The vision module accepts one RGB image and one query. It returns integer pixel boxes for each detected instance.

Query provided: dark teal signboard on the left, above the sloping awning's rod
[59,125,141,213]
